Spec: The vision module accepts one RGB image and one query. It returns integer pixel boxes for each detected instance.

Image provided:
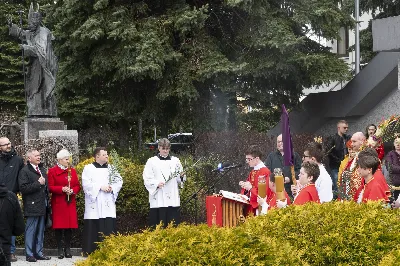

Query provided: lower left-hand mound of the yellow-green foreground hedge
[78,225,307,266]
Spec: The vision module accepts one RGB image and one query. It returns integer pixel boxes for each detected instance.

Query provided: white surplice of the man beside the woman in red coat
[82,164,123,219]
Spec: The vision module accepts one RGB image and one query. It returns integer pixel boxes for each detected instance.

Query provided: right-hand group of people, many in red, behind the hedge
[239,120,400,215]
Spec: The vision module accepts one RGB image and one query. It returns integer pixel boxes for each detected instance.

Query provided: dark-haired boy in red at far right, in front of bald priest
[356,155,389,203]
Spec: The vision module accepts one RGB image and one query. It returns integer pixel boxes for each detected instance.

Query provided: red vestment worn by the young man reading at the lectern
[240,167,272,214]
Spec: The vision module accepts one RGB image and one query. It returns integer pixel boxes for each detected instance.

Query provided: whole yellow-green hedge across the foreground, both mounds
[78,202,400,266]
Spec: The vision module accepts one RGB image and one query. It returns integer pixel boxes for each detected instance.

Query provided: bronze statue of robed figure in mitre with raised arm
[8,3,58,117]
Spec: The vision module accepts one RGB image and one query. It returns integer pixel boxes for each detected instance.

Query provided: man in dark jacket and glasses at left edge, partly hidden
[0,137,24,262]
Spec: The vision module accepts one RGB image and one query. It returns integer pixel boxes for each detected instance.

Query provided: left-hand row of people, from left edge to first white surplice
[0,140,123,265]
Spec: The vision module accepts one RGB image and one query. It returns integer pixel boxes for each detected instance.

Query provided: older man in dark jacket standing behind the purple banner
[265,134,302,198]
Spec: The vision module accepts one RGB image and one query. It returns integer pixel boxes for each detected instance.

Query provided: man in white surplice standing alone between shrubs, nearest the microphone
[143,138,186,228]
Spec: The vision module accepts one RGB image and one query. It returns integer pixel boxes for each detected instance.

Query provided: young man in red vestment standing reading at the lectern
[239,146,271,215]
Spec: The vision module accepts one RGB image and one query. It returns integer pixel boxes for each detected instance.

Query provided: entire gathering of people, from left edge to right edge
[0,120,400,265]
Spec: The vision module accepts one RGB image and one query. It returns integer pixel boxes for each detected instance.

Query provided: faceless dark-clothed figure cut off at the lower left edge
[0,183,25,266]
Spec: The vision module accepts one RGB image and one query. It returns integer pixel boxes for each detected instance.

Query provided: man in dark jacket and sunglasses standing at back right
[326,120,351,192]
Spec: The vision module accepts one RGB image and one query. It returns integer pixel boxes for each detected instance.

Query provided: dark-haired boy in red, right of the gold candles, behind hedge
[293,161,320,205]
